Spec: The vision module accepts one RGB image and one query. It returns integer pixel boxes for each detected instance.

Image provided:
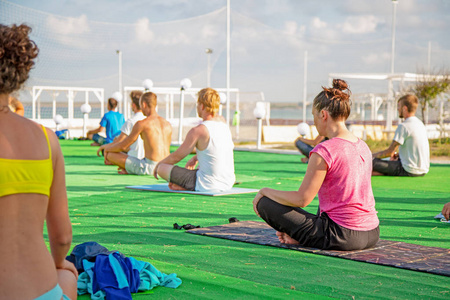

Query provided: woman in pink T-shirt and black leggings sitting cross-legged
[253,79,380,250]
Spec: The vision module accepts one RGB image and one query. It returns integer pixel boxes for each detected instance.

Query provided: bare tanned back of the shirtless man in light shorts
[140,115,172,161]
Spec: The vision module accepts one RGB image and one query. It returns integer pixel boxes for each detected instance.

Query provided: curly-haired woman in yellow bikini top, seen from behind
[0,24,78,300]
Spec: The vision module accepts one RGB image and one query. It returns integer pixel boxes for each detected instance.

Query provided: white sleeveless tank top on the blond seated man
[195,121,236,192]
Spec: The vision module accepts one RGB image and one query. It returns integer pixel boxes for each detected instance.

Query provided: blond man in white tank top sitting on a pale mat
[153,88,236,192]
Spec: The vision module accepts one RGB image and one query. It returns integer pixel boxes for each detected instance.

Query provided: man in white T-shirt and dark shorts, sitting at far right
[372,95,430,177]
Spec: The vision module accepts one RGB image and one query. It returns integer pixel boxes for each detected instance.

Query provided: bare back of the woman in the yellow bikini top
[0,112,67,299]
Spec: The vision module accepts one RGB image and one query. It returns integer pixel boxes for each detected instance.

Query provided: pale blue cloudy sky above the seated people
[0,0,450,102]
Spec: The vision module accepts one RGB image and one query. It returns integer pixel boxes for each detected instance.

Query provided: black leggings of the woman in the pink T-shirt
[257,197,380,251]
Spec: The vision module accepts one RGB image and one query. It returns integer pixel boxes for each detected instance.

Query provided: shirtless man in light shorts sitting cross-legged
[97,92,172,175]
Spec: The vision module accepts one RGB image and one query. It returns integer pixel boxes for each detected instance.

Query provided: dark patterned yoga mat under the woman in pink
[186,221,450,276]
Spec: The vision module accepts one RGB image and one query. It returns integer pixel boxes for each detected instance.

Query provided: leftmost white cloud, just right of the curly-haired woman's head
[47,15,90,35]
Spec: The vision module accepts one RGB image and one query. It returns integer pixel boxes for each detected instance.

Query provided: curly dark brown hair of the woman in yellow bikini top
[0,24,39,94]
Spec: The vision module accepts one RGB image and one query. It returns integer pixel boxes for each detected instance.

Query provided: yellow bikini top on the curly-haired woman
[0,126,53,197]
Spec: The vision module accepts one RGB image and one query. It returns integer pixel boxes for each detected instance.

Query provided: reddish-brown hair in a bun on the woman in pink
[313,79,352,120]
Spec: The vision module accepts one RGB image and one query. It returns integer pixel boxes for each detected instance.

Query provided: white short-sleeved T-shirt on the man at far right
[394,116,430,174]
